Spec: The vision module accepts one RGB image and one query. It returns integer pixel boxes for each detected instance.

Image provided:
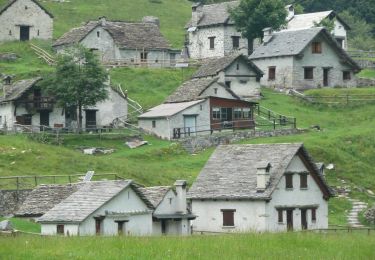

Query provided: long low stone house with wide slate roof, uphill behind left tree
[53,17,180,67]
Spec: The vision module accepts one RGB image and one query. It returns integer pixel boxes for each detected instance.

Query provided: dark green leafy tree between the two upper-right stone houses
[229,0,288,52]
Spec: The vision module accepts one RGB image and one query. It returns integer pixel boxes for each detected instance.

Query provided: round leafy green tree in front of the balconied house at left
[43,46,108,130]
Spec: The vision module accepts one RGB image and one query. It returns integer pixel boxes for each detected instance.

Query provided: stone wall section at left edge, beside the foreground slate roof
[0,190,32,216]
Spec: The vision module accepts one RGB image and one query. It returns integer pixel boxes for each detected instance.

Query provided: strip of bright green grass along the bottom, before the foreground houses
[0,233,375,259]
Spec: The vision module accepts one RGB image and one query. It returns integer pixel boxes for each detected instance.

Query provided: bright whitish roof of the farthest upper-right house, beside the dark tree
[288,10,350,30]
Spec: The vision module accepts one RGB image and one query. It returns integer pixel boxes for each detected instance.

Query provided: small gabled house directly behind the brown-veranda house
[192,54,263,100]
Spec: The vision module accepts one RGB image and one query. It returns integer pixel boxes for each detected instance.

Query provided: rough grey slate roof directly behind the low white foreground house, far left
[15,184,79,217]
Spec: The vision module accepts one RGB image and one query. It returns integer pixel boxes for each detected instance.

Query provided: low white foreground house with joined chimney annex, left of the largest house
[38,180,195,236]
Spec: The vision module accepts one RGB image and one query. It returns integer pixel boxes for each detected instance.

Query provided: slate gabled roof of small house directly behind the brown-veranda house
[193,54,263,78]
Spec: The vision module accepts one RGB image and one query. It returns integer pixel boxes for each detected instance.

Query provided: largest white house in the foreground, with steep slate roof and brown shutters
[187,144,333,232]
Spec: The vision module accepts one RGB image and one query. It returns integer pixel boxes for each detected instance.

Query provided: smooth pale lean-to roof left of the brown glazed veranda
[138,99,204,119]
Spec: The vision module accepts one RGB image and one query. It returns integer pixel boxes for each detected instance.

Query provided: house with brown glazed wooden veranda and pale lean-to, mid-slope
[138,78,256,140]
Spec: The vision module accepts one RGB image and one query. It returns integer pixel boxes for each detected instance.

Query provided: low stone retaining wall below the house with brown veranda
[178,129,305,153]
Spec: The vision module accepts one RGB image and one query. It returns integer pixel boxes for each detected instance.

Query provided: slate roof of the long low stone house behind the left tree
[53,21,171,50]
